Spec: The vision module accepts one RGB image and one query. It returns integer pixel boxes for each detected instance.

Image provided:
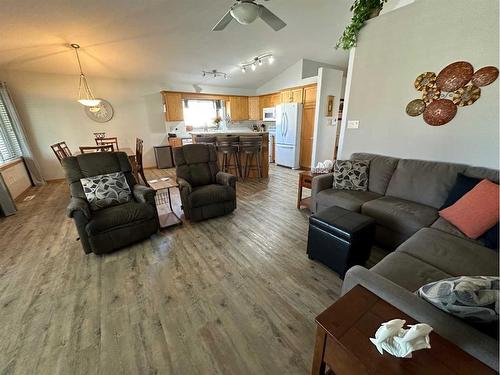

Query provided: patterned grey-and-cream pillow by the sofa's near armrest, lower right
[417,276,500,323]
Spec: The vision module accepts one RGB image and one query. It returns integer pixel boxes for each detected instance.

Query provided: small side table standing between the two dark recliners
[148,177,182,229]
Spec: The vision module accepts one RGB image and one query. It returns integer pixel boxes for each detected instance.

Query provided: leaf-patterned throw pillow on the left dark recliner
[80,172,132,211]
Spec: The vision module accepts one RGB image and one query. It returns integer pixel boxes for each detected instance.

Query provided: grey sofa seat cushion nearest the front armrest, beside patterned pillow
[371,251,454,292]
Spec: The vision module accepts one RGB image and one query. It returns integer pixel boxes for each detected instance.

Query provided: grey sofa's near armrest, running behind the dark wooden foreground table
[342,266,499,370]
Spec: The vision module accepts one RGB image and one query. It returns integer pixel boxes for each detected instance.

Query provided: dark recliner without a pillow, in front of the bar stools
[174,144,236,221]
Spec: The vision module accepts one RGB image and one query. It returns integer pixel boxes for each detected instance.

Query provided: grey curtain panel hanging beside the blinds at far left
[0,82,45,186]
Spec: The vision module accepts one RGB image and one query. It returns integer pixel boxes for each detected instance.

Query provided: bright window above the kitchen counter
[184,99,222,128]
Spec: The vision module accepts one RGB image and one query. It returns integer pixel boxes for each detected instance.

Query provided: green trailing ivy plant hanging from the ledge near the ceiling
[335,0,387,50]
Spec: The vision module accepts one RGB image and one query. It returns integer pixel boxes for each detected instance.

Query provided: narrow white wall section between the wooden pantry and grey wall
[311,68,344,166]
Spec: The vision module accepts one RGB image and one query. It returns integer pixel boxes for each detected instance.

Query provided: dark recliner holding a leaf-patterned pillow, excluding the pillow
[61,152,159,254]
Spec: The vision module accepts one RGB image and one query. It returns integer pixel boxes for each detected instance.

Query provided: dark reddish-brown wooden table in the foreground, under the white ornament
[311,285,496,375]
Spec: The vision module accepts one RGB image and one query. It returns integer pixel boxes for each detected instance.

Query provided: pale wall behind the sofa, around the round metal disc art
[341,0,499,168]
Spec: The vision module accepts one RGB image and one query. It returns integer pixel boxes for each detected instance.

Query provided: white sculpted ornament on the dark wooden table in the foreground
[370,319,432,358]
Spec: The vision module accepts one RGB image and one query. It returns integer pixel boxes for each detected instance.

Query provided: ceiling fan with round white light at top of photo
[212,0,286,31]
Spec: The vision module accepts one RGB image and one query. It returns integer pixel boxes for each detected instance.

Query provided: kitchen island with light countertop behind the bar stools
[190,129,269,178]
